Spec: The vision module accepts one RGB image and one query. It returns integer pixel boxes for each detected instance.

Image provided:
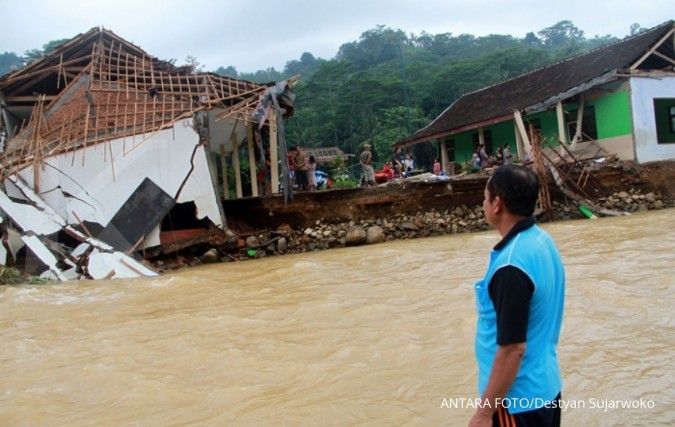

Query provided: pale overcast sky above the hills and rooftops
[0,0,675,72]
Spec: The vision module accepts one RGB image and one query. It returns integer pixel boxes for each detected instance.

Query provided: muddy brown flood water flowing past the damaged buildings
[0,209,675,426]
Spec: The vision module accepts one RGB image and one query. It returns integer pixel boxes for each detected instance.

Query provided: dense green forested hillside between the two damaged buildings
[260,21,615,163]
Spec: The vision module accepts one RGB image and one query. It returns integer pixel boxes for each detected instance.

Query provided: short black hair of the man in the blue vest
[487,165,539,217]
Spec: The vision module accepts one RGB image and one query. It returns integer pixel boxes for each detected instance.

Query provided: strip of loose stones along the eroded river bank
[152,187,675,272]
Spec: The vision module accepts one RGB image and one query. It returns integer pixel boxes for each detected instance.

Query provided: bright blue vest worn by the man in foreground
[475,218,565,414]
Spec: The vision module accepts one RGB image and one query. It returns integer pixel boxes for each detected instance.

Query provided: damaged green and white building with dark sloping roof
[402,21,675,171]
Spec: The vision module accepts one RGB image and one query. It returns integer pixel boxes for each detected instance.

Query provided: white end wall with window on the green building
[630,76,675,163]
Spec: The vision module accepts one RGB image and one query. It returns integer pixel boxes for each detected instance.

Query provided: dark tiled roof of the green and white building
[397,21,675,145]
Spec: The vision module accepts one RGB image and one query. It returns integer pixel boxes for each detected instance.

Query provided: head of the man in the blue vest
[483,165,539,225]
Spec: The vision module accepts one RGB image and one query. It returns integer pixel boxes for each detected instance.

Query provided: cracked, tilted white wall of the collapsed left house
[21,119,222,231]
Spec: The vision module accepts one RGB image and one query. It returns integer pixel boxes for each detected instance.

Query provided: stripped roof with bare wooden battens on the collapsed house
[0,28,297,178]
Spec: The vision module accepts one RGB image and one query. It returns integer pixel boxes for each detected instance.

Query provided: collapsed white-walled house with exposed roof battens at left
[0,28,297,280]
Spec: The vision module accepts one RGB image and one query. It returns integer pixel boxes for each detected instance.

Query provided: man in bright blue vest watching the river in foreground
[469,165,565,427]
